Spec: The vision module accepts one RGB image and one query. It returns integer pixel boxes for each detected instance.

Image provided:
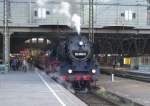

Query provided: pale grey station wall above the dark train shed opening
[0,0,150,28]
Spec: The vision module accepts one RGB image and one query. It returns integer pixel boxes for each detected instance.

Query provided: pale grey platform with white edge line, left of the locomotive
[0,71,86,106]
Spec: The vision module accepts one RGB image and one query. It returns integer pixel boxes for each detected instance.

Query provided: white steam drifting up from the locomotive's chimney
[36,0,81,34]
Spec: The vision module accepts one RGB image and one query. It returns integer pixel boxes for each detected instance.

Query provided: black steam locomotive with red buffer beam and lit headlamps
[48,36,100,90]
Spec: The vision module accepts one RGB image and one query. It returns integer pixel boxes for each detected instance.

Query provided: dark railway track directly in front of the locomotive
[75,92,116,106]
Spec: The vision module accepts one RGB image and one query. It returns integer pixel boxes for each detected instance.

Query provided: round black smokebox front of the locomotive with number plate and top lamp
[67,36,92,61]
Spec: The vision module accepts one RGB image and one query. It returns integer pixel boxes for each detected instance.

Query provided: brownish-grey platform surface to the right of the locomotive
[97,75,150,106]
